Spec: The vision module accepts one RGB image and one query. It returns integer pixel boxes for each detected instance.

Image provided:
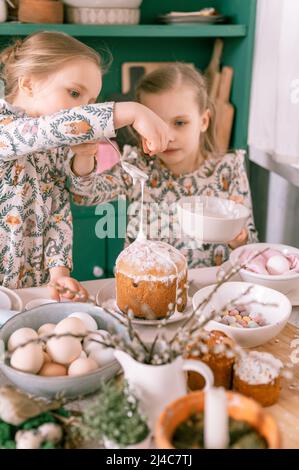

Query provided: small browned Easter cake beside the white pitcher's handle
[188,330,235,390]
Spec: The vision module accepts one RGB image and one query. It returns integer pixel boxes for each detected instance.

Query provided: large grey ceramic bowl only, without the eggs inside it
[0,302,125,398]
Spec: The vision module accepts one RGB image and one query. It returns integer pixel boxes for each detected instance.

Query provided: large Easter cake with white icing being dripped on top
[115,240,187,320]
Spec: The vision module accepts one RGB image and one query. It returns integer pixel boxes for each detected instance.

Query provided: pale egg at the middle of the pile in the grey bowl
[47,336,82,365]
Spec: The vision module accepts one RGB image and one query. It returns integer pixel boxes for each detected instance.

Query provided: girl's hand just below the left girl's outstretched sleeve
[71,142,99,176]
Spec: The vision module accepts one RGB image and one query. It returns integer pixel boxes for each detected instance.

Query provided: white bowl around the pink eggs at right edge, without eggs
[229,243,299,294]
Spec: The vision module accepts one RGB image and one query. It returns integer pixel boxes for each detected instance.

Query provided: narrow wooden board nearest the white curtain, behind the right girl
[215,67,235,153]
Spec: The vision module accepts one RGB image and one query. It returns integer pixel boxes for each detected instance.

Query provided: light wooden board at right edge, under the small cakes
[254,323,299,449]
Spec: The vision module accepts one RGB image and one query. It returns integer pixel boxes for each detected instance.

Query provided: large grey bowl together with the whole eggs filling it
[0,302,126,398]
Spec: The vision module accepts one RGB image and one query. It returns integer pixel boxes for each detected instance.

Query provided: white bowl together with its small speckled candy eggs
[192,282,292,348]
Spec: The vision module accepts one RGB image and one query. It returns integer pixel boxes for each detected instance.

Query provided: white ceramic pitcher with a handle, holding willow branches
[114,350,214,428]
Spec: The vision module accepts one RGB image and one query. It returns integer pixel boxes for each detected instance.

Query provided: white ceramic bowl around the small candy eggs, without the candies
[192,282,292,348]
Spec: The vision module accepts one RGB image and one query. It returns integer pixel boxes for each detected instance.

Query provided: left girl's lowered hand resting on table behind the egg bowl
[48,267,88,302]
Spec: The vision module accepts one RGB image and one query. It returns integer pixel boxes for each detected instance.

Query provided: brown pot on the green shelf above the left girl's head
[18,0,63,23]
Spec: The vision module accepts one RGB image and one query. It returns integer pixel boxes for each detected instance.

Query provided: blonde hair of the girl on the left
[0,31,102,99]
